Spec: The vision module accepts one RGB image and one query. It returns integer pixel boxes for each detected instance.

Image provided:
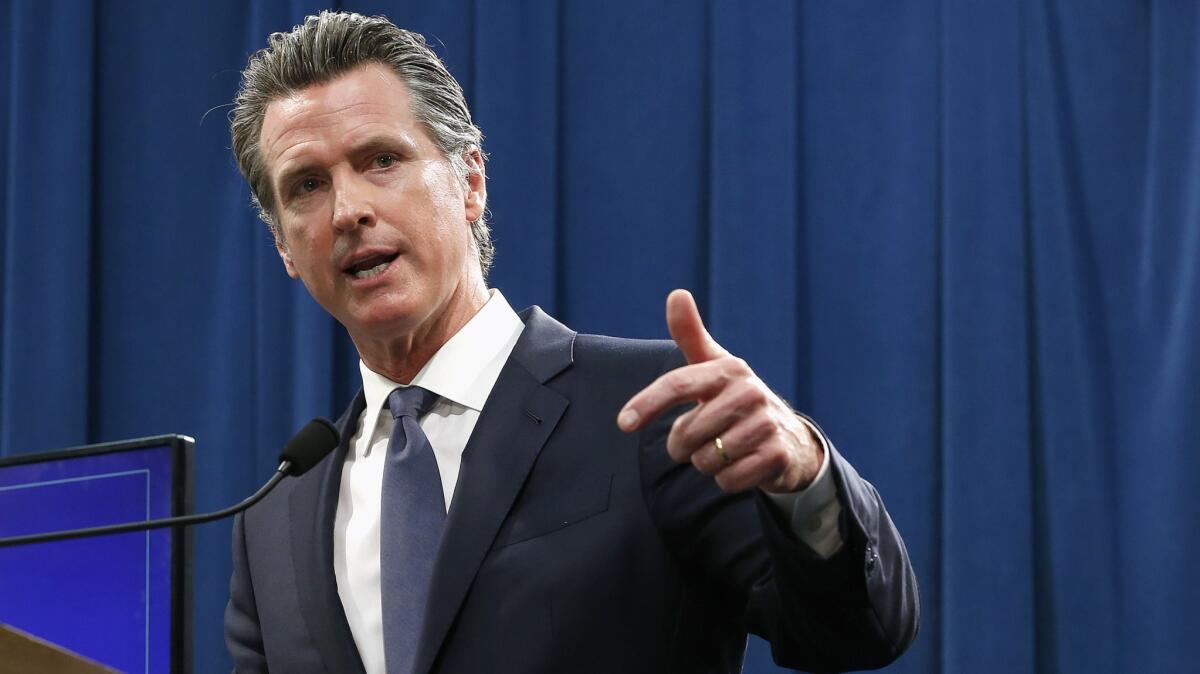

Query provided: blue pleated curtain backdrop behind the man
[0,0,1200,674]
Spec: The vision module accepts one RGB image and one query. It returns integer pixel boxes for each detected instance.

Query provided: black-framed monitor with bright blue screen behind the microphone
[0,435,191,673]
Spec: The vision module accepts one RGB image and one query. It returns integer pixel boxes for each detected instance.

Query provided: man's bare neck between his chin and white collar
[350,279,488,384]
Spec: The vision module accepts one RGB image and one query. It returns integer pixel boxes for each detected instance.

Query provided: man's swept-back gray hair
[229,11,496,278]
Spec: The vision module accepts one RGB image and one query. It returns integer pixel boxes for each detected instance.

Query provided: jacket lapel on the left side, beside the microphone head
[288,391,366,673]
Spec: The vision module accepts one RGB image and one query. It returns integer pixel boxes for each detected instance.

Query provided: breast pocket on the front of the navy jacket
[492,474,612,550]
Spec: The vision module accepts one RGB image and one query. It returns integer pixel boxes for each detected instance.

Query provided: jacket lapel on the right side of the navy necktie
[416,307,575,672]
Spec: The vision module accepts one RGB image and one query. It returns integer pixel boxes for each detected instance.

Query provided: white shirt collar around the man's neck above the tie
[359,289,524,419]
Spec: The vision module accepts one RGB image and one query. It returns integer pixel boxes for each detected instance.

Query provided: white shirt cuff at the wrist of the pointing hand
[767,417,842,559]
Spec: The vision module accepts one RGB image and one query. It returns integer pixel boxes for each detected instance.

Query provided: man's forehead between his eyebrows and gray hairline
[259,64,425,170]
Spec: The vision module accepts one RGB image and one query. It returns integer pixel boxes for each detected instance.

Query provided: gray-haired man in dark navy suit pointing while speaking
[226,13,918,673]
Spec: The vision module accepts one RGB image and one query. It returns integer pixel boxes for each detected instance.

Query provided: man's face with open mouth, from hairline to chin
[260,64,486,343]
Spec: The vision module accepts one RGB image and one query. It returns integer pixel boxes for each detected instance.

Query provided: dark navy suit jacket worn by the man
[226,307,918,674]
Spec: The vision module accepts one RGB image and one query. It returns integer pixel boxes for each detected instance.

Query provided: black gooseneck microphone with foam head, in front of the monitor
[0,417,340,548]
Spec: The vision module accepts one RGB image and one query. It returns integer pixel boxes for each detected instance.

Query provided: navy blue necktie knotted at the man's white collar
[379,386,446,674]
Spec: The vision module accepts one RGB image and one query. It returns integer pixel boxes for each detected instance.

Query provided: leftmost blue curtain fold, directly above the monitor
[0,2,98,452]
